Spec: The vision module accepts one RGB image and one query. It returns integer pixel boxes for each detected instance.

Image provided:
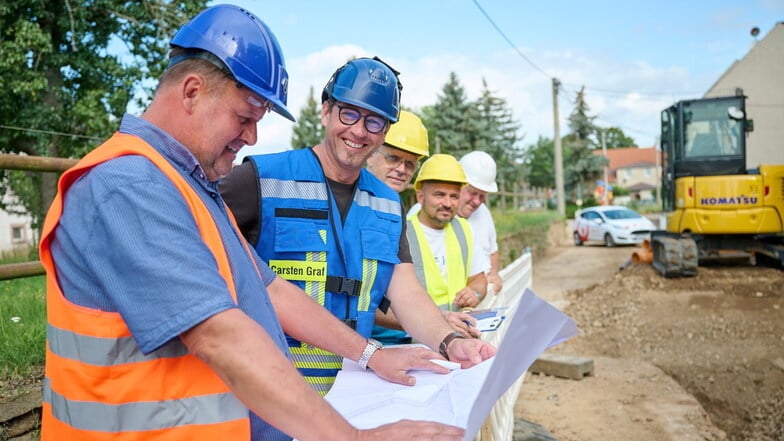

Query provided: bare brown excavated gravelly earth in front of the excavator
[566,265,784,441]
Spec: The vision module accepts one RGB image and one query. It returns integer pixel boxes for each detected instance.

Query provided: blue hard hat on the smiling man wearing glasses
[321,57,403,122]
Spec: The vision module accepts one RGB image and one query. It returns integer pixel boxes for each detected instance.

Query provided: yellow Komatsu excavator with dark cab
[650,89,784,277]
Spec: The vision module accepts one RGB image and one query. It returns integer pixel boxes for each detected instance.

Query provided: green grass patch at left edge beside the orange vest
[0,276,46,380]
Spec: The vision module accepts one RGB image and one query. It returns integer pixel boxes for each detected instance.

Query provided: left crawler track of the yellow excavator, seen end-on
[651,235,699,277]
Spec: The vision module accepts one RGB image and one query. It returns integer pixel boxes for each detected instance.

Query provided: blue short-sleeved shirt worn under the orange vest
[51,115,290,441]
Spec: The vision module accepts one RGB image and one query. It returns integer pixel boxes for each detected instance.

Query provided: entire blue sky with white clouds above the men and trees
[204,0,784,161]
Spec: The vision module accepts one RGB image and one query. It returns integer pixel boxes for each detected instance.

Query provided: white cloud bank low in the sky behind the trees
[241,40,728,162]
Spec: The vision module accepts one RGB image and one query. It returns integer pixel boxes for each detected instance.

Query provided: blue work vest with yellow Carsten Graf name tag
[250,149,403,393]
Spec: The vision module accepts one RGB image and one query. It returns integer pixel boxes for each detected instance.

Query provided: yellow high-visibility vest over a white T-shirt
[406,214,473,310]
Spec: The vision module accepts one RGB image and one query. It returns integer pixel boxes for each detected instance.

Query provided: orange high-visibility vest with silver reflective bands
[40,133,250,441]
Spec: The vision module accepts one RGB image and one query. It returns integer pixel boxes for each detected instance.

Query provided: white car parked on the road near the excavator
[573,205,656,247]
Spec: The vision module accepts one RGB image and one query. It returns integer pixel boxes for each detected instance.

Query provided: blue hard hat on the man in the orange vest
[171,5,294,121]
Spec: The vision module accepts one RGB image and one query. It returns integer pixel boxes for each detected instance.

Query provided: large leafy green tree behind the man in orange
[0,0,206,227]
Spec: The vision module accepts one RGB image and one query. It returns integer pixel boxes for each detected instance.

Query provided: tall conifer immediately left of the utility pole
[469,79,523,191]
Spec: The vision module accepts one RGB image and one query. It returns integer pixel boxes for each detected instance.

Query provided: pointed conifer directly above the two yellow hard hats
[420,72,476,157]
